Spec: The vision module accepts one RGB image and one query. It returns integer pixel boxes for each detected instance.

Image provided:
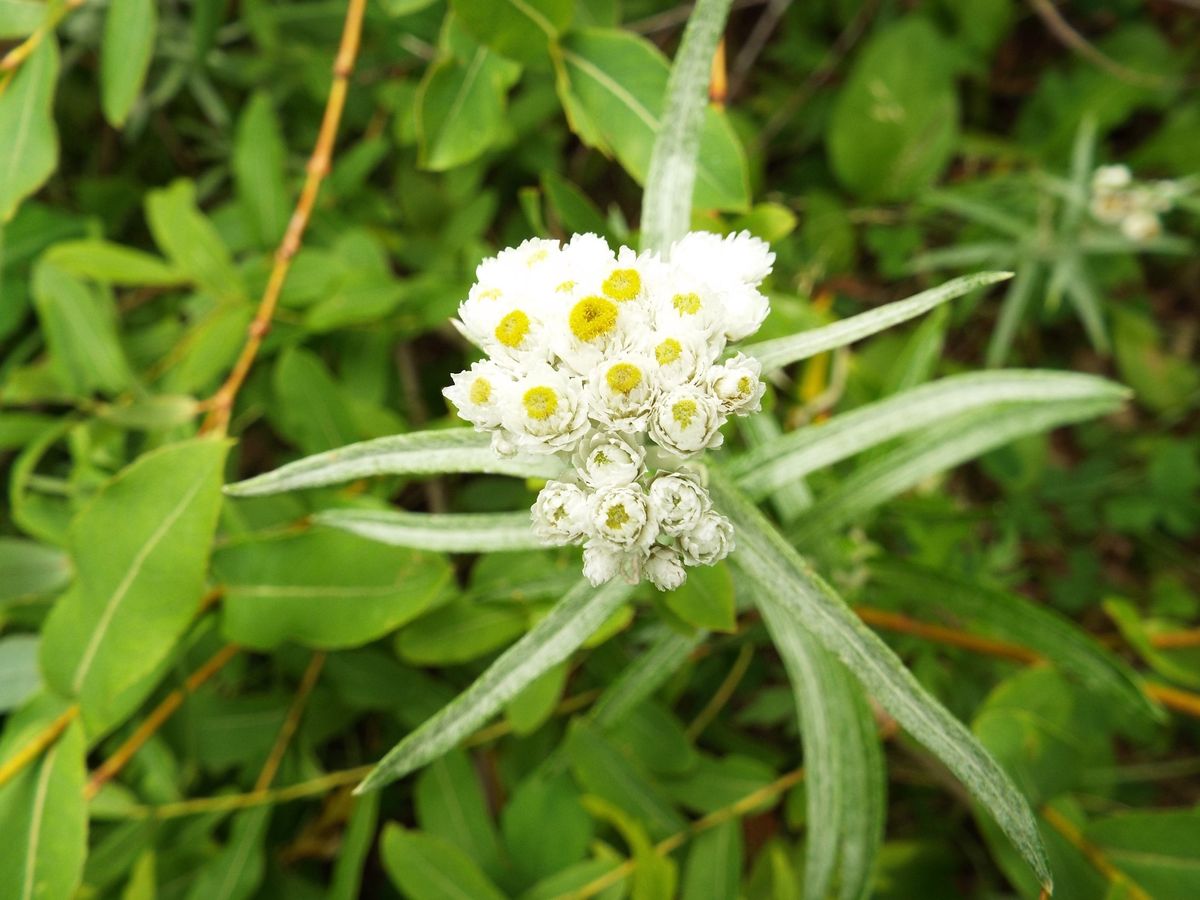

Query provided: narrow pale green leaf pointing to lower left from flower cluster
[358,581,632,793]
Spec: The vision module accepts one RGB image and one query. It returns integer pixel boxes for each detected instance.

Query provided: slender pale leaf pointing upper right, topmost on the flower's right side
[742,272,1013,371]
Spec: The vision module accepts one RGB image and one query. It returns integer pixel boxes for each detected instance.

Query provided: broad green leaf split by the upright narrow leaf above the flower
[559,29,750,211]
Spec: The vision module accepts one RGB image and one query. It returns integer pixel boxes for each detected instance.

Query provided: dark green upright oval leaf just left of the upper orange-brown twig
[232,91,292,247]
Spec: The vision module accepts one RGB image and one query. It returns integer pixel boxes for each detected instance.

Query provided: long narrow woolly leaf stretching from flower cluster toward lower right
[710,472,1051,887]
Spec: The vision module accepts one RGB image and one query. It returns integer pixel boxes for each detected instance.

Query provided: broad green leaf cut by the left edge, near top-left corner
[0,36,59,224]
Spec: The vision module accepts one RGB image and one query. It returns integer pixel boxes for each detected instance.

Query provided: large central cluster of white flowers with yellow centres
[443,232,775,590]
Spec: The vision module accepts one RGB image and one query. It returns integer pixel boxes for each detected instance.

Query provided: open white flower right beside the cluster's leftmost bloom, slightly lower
[502,364,588,454]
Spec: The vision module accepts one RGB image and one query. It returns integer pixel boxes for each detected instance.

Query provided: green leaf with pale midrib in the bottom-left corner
[0,713,88,900]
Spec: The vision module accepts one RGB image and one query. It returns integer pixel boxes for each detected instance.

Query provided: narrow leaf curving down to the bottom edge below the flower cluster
[760,607,886,900]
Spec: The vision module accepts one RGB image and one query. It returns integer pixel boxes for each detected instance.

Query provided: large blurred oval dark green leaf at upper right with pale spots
[826,16,959,200]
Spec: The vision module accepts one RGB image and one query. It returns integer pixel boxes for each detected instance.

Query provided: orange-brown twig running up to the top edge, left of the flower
[200,0,366,434]
